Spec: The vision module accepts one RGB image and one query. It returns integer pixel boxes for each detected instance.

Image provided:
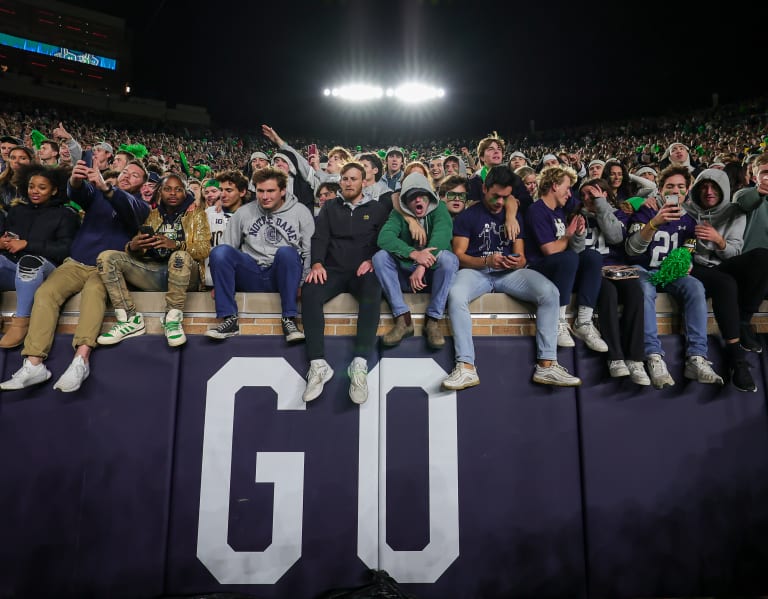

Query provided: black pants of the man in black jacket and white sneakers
[301,269,381,360]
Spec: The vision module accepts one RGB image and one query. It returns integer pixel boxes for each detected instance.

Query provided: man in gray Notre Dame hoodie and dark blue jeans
[205,167,315,343]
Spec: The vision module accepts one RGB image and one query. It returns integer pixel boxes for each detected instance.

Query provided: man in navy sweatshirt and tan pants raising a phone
[0,160,149,393]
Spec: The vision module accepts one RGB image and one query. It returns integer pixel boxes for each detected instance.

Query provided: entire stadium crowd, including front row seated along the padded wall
[0,92,768,403]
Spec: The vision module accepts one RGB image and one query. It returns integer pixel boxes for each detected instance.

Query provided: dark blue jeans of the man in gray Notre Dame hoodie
[209,245,303,318]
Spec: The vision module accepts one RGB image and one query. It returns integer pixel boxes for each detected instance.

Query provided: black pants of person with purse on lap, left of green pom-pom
[597,277,645,362]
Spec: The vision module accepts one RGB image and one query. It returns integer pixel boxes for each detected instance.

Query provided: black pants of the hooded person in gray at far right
[691,248,768,340]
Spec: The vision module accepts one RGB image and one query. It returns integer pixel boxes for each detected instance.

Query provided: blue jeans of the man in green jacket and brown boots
[373,250,459,320]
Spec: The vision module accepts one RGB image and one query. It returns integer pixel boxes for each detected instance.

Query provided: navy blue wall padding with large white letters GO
[0,335,768,599]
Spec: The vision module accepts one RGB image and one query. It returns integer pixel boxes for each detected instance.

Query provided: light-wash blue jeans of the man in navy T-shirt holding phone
[448,268,560,364]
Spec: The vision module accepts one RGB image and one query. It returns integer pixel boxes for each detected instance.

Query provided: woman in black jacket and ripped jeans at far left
[0,164,80,349]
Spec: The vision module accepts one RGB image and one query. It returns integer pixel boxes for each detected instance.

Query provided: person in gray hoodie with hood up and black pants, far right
[683,168,768,392]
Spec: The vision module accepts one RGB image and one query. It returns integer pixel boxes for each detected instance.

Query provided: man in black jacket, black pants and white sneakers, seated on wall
[301,162,392,404]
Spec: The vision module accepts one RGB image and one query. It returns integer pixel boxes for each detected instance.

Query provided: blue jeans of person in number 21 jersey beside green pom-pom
[637,266,708,357]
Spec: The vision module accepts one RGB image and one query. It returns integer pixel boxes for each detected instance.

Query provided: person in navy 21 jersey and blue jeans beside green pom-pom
[625,166,723,389]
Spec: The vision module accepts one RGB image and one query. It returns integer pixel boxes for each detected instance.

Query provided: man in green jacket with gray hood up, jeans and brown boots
[373,172,459,349]
